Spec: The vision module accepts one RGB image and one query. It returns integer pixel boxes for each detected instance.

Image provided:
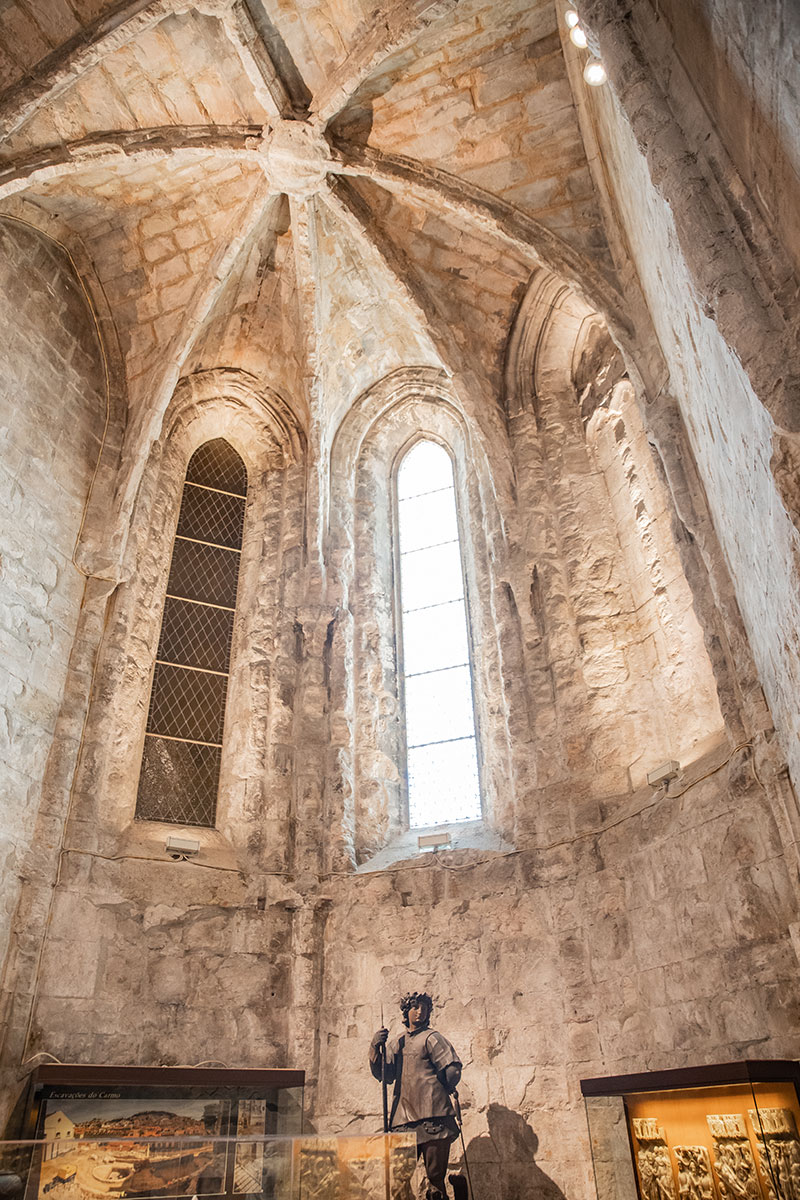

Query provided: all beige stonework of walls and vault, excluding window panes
[0,0,800,1200]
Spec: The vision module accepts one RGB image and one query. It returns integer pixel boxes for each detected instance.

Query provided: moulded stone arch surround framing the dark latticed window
[67,370,305,854]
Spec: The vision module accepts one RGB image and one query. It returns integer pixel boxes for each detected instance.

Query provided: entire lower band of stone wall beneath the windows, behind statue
[7,739,800,1200]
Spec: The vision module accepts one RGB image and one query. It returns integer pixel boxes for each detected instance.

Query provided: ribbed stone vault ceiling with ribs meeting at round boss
[0,0,614,448]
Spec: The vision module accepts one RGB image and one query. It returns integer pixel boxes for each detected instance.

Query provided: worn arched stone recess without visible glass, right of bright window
[506,274,723,791]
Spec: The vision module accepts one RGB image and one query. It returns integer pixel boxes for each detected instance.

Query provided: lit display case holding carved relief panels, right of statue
[581,1060,800,1200]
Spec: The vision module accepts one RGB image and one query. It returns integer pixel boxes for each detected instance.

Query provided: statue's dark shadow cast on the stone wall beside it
[451,1104,565,1200]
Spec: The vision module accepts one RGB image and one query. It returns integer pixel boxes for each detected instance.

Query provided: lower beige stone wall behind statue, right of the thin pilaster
[314,752,800,1200]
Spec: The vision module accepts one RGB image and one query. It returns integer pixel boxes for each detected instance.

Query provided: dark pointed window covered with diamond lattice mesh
[136,438,247,826]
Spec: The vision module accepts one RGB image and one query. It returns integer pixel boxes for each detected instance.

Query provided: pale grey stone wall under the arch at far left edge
[0,220,106,974]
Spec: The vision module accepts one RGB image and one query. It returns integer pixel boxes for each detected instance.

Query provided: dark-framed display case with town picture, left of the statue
[24,1066,305,1200]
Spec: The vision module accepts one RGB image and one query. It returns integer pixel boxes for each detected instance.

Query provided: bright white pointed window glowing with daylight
[397,442,481,828]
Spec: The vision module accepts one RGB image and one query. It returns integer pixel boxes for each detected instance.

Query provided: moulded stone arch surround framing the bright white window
[330,367,515,863]
